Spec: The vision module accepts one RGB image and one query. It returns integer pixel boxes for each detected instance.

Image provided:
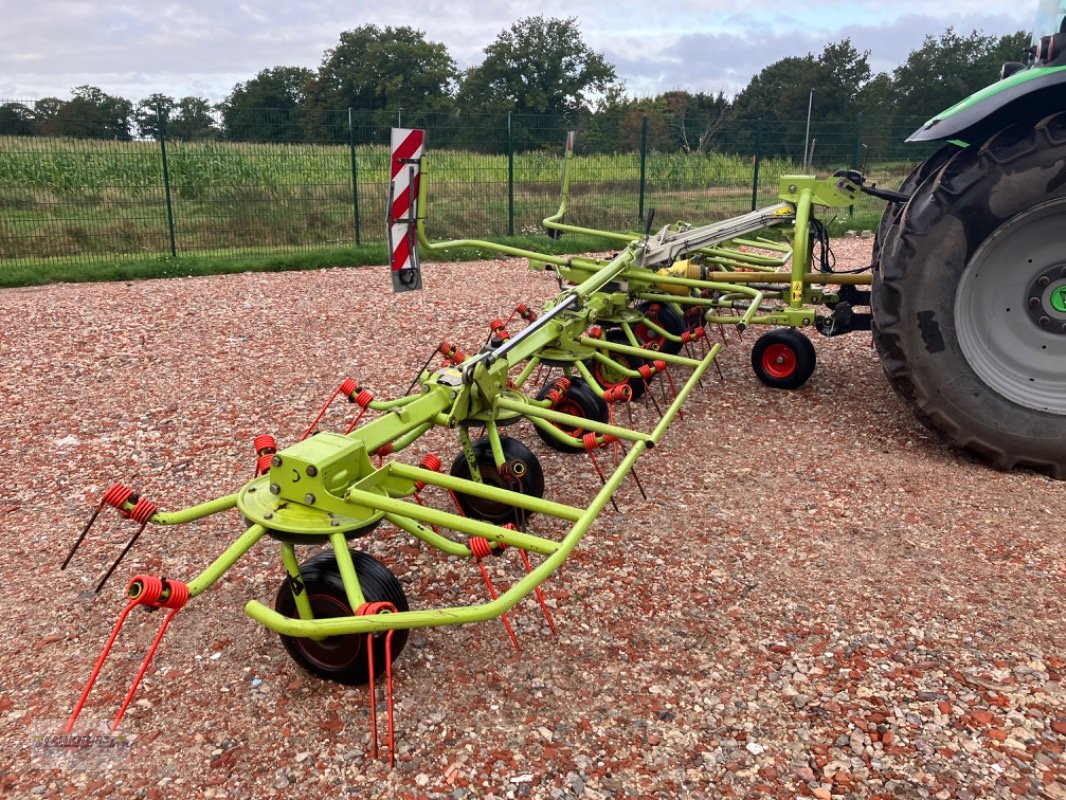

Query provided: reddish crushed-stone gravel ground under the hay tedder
[0,240,1066,800]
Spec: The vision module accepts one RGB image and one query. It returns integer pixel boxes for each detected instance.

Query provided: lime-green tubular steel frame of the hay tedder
[93,130,869,639]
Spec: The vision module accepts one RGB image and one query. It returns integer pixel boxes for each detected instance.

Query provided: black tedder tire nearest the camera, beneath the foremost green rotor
[274,549,408,686]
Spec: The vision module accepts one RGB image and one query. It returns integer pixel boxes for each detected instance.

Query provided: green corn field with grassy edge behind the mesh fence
[0,118,925,265]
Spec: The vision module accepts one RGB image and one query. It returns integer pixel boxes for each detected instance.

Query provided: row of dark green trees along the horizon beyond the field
[0,16,1029,153]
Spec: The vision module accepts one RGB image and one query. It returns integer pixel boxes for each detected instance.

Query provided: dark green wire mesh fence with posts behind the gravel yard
[0,110,928,266]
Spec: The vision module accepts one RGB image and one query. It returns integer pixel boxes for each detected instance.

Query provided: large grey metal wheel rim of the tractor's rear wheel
[955,198,1066,415]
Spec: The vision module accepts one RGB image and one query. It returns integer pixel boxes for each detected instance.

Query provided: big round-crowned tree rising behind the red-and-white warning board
[308,25,457,139]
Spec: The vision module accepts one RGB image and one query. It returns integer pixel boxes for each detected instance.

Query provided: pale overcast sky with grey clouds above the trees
[0,0,1036,102]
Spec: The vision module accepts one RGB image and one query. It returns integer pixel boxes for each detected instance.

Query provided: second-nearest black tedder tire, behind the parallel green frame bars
[450,436,544,528]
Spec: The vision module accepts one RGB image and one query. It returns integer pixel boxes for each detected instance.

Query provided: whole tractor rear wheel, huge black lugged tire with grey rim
[872,113,1066,478]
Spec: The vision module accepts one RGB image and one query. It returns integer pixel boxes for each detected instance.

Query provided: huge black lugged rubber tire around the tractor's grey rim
[872,114,1066,478]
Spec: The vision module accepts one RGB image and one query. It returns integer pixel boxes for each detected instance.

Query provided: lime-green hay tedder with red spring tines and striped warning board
[64,130,882,763]
